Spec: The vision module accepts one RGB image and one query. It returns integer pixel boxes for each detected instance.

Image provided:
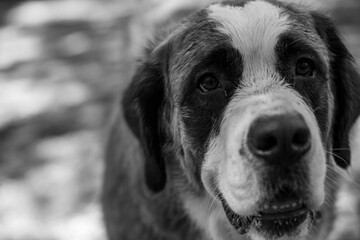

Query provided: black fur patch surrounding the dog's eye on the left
[181,45,242,156]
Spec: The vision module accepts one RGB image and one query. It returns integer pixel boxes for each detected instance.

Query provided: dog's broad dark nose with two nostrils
[248,113,311,166]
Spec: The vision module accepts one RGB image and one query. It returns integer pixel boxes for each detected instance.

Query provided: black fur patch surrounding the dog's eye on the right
[275,32,330,142]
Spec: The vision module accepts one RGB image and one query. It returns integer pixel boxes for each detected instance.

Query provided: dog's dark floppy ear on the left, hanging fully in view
[122,43,167,193]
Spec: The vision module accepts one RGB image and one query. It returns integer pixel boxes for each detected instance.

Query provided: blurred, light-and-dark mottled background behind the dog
[0,0,360,240]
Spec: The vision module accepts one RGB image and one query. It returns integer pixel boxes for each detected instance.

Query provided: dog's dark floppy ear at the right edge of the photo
[312,12,360,168]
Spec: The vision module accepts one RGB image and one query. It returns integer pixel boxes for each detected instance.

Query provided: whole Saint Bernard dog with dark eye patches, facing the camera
[102,0,360,240]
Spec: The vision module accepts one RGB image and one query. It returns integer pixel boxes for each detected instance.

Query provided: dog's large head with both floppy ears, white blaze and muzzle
[123,0,360,239]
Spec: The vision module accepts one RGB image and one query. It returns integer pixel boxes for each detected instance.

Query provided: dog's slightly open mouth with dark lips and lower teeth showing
[220,197,313,239]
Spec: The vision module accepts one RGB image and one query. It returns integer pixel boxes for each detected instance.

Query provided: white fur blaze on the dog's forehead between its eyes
[209,1,290,80]
